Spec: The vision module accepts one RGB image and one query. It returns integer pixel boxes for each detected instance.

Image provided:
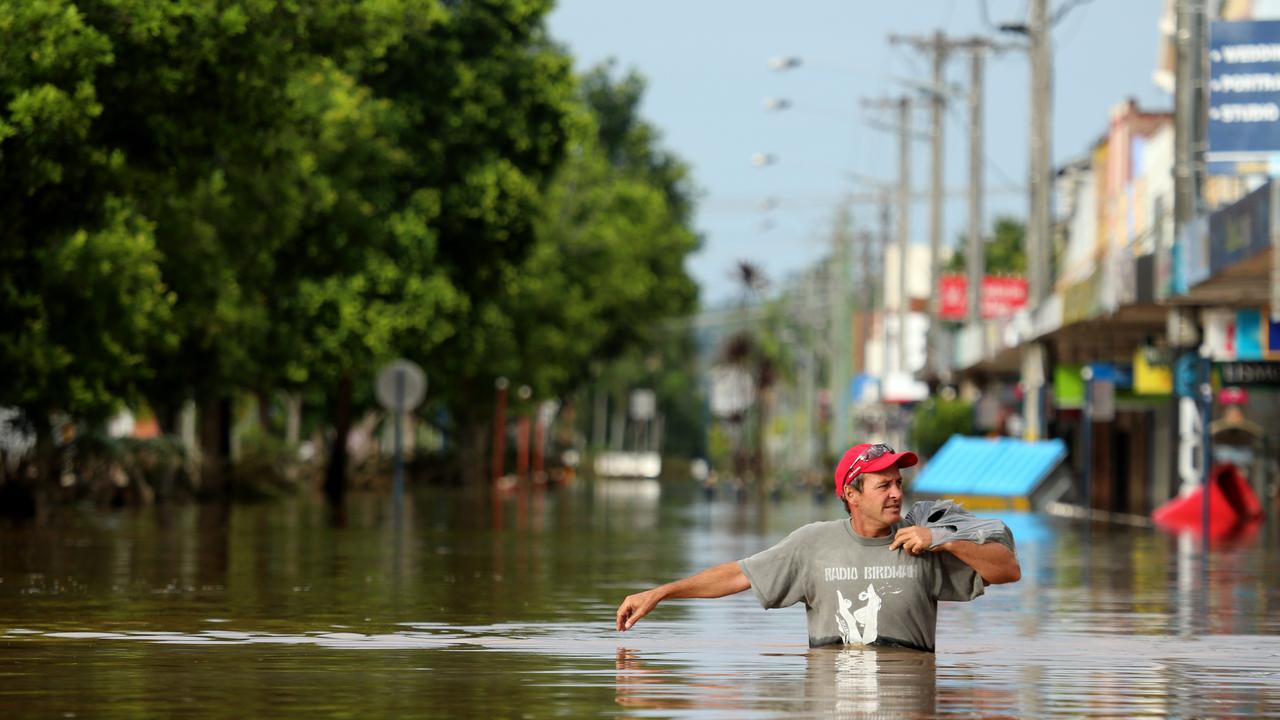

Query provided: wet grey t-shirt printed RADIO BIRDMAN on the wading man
[739,520,983,652]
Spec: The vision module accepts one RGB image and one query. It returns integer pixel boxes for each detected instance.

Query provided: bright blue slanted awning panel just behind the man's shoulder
[911,436,1066,509]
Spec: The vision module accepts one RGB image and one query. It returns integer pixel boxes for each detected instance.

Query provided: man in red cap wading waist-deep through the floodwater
[617,445,1021,652]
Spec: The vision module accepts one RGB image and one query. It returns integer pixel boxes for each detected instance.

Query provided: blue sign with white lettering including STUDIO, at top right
[1206,20,1280,174]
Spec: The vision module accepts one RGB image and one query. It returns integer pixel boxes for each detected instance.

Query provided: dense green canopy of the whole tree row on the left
[0,0,699,481]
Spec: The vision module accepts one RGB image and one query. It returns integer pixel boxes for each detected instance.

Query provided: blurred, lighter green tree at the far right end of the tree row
[537,63,703,455]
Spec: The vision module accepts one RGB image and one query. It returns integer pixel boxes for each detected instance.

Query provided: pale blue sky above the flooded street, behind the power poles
[549,0,1172,305]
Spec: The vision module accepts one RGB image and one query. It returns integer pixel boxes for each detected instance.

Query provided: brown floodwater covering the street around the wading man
[0,482,1280,720]
